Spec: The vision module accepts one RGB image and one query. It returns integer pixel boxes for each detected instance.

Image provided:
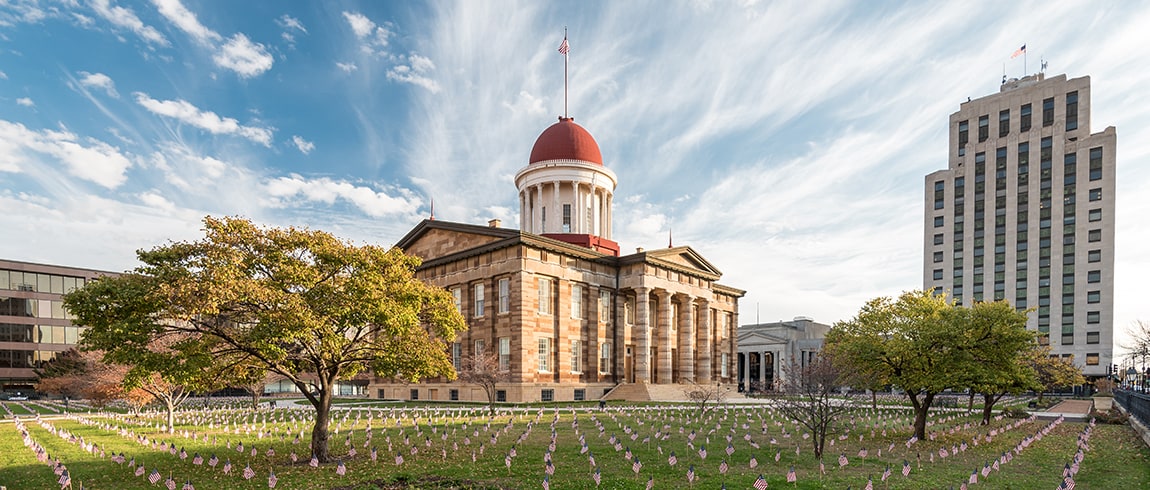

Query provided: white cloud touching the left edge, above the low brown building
[0,120,132,189]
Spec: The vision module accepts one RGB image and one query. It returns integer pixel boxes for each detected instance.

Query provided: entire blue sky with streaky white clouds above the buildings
[0,0,1150,349]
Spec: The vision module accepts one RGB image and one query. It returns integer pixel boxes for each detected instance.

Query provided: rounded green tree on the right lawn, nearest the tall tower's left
[826,291,1021,439]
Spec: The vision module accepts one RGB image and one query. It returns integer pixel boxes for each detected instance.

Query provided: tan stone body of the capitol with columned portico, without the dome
[368,220,744,401]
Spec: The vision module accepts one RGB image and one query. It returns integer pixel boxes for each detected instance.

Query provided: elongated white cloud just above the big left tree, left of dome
[265,174,421,217]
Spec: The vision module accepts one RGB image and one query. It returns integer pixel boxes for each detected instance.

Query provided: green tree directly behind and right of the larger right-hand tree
[955,301,1038,424]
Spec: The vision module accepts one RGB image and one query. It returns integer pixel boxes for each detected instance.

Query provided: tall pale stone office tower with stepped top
[922,74,1117,376]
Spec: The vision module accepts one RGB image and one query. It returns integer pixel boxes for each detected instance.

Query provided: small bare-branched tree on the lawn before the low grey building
[774,353,853,459]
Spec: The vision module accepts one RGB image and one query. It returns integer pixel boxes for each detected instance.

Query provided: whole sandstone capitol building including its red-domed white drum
[368,117,745,401]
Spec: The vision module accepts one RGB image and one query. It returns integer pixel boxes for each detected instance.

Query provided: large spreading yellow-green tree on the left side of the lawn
[64,216,466,461]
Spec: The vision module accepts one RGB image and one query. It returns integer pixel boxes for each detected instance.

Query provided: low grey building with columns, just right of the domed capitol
[738,316,830,392]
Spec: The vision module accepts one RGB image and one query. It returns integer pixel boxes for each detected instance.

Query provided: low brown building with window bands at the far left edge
[0,260,115,390]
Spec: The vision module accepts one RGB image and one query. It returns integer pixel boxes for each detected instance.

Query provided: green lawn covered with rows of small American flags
[0,405,1150,490]
